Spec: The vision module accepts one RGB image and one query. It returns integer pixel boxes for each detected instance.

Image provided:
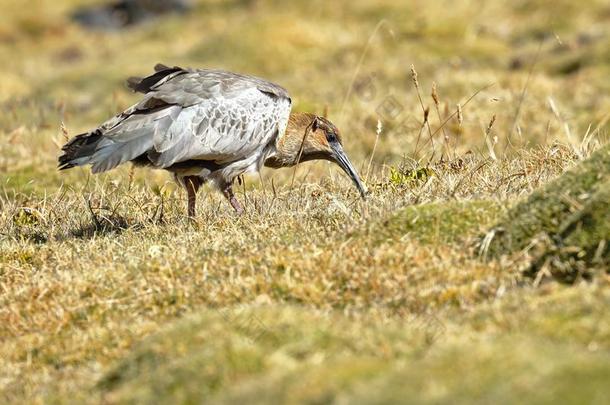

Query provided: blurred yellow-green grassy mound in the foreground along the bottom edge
[81,286,610,404]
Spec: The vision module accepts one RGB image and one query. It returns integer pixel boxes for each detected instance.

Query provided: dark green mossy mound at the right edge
[489,145,610,281]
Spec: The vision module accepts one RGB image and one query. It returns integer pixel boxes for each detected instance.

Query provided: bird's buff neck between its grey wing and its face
[265,112,315,168]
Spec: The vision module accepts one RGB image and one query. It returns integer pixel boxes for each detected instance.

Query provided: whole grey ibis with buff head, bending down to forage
[58,64,367,218]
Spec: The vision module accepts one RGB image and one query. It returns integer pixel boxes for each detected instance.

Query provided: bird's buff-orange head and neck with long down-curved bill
[265,113,367,198]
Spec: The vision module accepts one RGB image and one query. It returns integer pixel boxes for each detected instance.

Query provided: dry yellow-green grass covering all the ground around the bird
[0,0,610,403]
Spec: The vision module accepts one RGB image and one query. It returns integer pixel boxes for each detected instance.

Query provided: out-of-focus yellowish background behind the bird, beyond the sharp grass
[0,0,610,191]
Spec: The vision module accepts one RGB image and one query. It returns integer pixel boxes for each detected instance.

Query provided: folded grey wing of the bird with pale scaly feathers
[87,66,291,172]
